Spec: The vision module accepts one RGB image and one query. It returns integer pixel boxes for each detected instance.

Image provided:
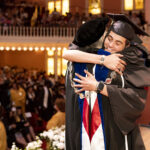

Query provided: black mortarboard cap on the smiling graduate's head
[107,13,149,43]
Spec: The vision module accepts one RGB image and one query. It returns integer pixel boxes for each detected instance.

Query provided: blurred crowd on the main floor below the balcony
[0,66,65,148]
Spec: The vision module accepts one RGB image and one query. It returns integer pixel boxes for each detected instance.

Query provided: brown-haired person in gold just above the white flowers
[46,98,65,130]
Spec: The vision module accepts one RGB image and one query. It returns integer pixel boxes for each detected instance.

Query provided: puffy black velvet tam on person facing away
[73,17,109,47]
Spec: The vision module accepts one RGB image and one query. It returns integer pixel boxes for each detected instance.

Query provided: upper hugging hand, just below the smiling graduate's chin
[103,54,126,75]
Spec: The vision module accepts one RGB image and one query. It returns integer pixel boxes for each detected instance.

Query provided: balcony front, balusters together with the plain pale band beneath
[0,25,150,49]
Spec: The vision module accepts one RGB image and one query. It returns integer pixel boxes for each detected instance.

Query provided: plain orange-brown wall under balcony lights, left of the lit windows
[0,51,46,70]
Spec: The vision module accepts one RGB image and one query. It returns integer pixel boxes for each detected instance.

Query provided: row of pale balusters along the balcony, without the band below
[0,26,77,37]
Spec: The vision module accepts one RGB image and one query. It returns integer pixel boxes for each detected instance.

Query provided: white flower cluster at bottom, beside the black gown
[11,125,65,150]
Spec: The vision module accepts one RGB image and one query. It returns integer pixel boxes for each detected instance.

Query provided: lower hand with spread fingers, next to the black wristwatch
[73,70,98,93]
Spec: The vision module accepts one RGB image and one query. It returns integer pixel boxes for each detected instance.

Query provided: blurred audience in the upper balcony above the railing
[0,0,146,28]
